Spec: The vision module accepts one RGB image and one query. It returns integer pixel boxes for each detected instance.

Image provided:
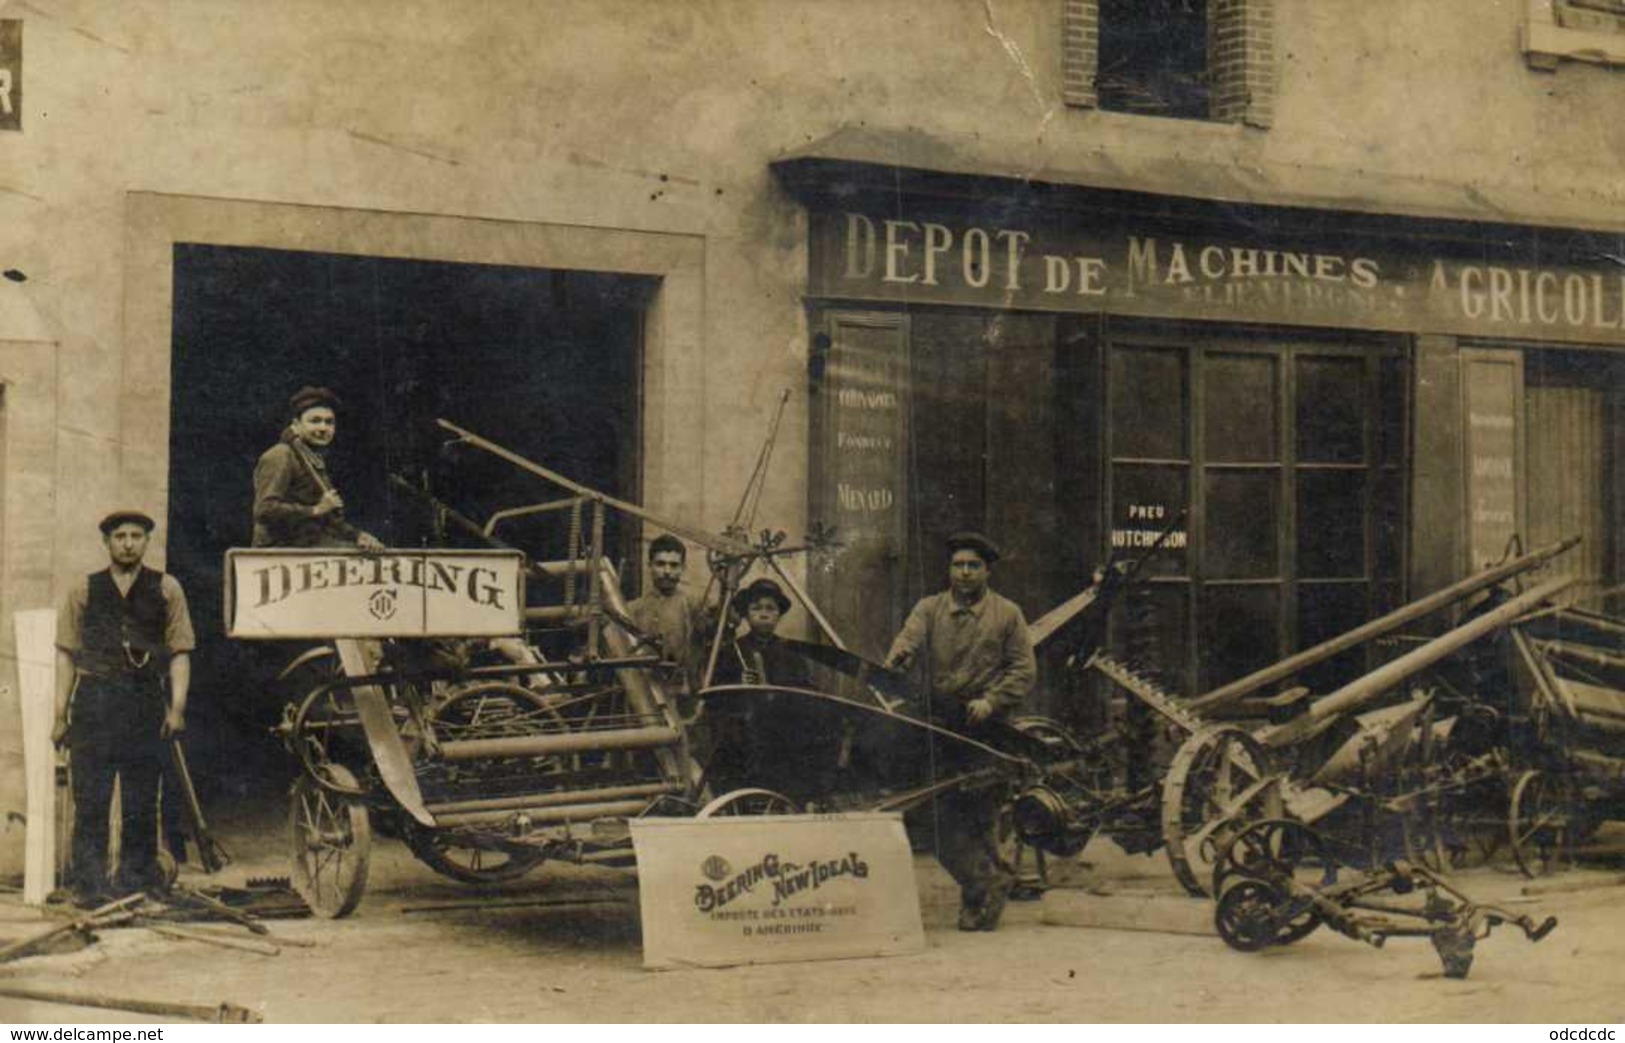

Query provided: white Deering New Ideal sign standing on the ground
[632,812,925,967]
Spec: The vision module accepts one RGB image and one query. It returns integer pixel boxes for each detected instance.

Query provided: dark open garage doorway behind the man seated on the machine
[167,242,658,798]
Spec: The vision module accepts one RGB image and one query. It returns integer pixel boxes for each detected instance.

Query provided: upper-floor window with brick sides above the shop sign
[1061,0,1274,127]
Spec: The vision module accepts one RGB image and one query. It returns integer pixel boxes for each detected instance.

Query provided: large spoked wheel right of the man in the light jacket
[1162,728,1271,897]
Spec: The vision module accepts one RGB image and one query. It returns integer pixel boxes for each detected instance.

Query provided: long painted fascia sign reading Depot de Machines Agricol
[811,211,1625,343]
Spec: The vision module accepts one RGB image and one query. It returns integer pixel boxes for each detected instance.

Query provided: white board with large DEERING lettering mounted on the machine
[226,547,525,638]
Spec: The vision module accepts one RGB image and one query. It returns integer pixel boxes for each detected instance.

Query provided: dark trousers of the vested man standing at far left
[68,677,164,894]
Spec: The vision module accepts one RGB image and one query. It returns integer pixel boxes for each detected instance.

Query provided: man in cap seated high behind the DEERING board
[254,387,384,551]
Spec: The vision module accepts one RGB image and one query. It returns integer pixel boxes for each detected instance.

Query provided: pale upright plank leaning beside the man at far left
[13,609,59,905]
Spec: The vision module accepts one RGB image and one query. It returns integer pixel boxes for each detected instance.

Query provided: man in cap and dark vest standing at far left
[54,510,197,907]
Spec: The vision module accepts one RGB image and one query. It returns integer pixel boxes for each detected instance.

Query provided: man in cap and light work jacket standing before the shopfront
[886,533,1038,931]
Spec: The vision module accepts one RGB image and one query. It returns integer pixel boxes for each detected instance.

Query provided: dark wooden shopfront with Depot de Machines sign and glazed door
[775,156,1625,708]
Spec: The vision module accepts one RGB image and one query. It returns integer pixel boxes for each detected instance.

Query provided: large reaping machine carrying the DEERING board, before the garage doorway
[226,421,1081,916]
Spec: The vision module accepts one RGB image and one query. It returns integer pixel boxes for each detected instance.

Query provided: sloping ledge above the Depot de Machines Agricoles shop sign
[770,127,1625,249]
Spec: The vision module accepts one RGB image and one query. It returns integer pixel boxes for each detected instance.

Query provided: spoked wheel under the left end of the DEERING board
[288,764,372,920]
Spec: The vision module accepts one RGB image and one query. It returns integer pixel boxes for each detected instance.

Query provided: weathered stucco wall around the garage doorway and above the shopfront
[0,0,1625,877]
